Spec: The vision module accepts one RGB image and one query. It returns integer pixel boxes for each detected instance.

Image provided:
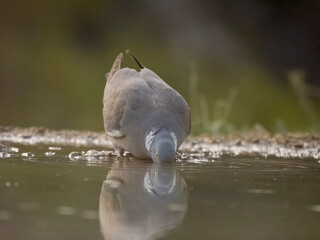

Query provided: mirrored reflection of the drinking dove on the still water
[99,164,188,240]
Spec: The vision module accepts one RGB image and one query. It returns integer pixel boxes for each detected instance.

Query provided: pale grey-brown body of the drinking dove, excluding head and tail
[103,55,190,158]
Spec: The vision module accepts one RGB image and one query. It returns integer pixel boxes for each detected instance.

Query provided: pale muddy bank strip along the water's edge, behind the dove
[0,126,320,160]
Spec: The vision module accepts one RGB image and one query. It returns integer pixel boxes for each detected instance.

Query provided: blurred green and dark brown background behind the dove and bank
[0,0,320,134]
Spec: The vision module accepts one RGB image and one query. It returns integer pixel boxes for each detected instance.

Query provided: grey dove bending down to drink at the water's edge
[103,50,191,162]
